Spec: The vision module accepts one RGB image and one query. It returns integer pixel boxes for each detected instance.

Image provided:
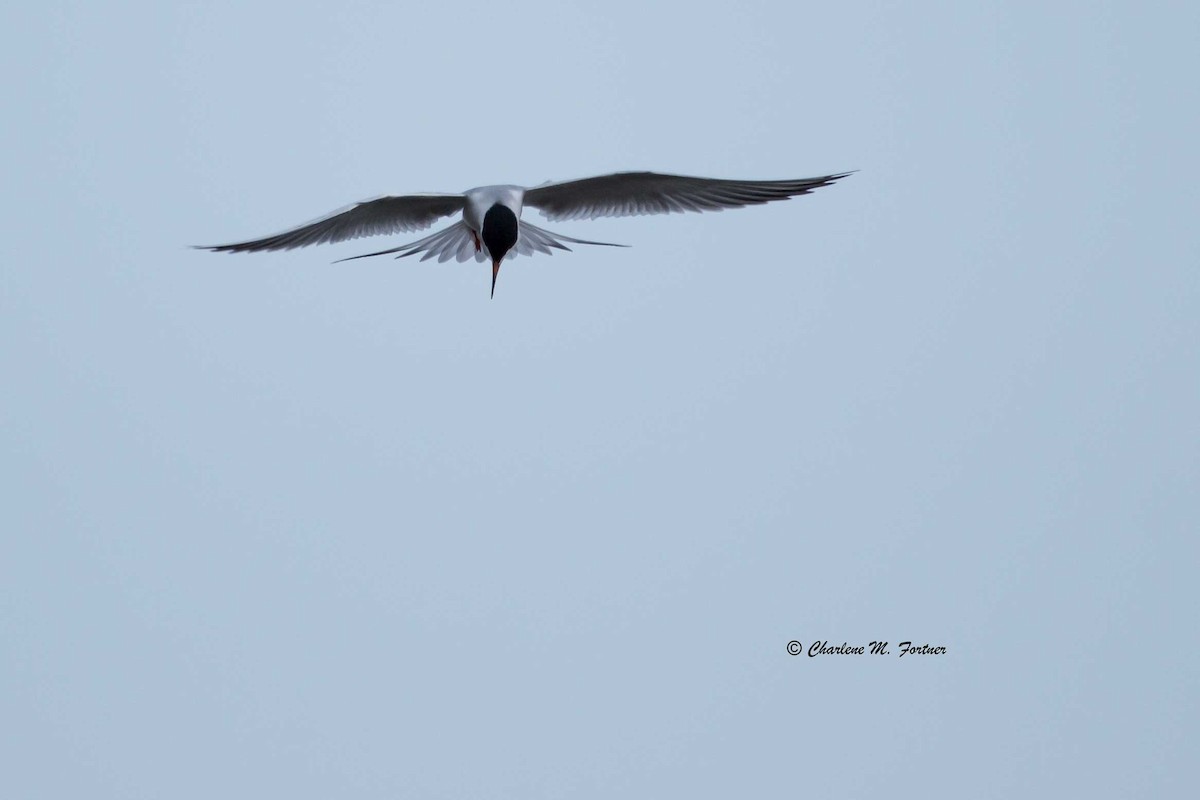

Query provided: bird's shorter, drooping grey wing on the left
[199,194,466,253]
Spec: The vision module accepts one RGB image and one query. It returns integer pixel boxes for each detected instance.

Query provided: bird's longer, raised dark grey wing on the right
[524,173,851,219]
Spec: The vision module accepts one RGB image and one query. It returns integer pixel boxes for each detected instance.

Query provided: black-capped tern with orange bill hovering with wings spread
[197,172,852,299]
